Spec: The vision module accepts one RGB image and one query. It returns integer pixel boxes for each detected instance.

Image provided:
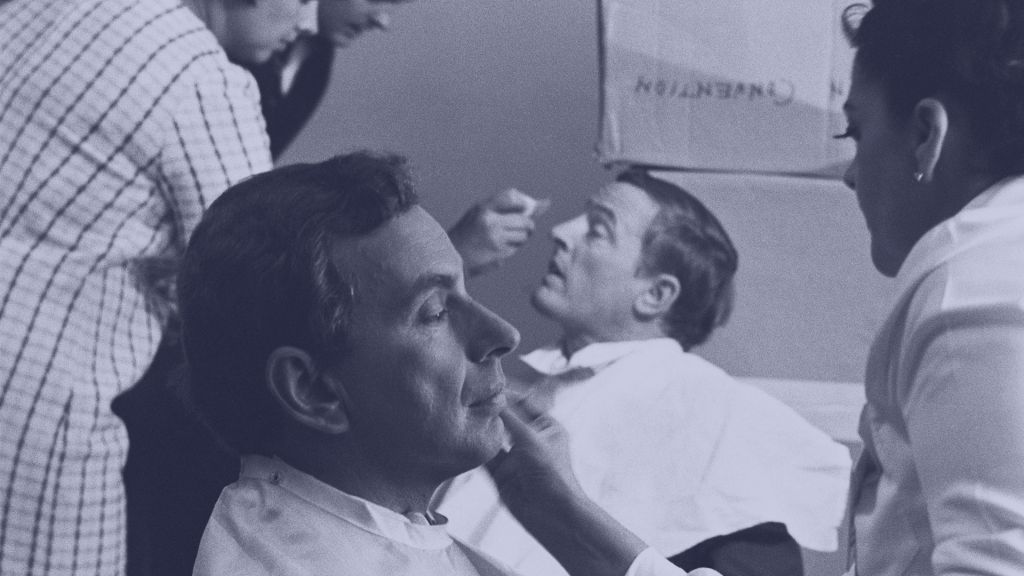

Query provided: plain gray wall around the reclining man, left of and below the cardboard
[284,0,890,381]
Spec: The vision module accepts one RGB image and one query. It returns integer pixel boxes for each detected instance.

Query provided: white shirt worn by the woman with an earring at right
[851,178,1024,576]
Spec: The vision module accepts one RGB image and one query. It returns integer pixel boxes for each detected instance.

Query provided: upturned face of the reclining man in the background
[532,182,658,340]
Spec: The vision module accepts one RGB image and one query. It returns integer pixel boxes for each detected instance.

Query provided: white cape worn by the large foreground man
[193,455,513,576]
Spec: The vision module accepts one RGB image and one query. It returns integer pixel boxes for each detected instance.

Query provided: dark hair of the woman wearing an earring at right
[844,0,1024,176]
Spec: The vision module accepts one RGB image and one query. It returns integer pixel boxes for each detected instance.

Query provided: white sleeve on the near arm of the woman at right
[903,305,1024,576]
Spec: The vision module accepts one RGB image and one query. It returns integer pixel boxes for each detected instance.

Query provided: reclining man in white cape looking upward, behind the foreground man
[439,170,850,576]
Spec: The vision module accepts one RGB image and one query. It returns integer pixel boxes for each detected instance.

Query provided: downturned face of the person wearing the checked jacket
[221,0,307,64]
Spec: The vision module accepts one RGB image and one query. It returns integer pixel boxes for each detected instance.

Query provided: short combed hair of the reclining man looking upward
[615,169,738,349]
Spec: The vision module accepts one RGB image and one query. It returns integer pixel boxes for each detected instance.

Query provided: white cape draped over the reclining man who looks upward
[439,338,850,575]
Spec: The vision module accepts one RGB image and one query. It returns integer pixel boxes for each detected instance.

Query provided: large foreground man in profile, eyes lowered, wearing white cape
[179,153,518,576]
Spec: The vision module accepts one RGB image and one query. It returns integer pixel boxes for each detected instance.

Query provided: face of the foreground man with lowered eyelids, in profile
[330,206,519,479]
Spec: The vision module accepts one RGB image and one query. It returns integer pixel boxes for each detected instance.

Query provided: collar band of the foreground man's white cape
[240,454,452,549]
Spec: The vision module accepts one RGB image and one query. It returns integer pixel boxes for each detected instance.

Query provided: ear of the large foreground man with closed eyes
[266,346,349,434]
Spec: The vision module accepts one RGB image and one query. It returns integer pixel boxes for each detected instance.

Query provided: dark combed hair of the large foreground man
[178,152,418,453]
